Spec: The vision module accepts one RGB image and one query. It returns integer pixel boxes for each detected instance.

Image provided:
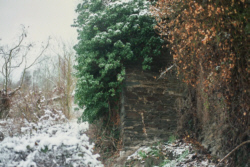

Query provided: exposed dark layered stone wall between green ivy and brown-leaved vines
[121,61,187,151]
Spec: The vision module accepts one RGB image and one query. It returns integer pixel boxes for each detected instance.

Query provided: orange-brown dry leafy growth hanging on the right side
[151,0,250,164]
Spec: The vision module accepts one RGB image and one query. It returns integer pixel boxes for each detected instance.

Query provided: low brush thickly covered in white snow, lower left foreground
[0,110,103,167]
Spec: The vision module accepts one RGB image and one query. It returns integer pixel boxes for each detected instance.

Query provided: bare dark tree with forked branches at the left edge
[0,28,49,119]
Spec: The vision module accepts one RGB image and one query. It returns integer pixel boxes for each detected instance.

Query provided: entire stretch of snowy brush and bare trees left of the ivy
[0,33,102,167]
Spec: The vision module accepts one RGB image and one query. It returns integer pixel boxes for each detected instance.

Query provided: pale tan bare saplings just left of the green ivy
[28,40,76,118]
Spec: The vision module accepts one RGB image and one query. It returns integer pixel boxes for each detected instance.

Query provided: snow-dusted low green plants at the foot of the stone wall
[126,140,217,167]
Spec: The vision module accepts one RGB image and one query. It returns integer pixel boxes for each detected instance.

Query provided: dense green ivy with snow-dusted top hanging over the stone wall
[74,0,162,122]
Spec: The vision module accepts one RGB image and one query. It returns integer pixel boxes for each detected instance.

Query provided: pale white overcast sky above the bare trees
[0,0,81,83]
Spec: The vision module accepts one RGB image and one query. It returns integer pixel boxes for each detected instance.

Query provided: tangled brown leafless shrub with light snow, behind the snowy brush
[0,88,67,136]
